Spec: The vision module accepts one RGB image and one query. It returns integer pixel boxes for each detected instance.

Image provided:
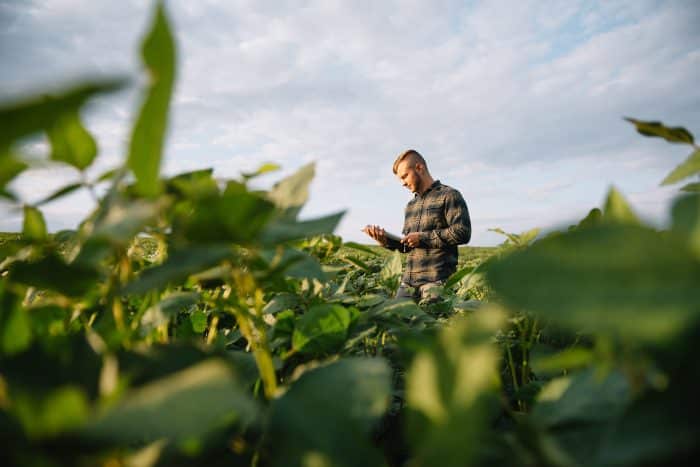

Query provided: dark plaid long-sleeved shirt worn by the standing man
[387,180,472,287]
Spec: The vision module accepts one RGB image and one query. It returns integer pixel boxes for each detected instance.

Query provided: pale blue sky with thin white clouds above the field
[0,0,700,246]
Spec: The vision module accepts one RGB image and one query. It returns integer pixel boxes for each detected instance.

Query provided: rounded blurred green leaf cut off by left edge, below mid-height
[0,281,32,355]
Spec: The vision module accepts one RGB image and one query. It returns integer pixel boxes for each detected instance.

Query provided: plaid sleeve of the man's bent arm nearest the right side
[421,190,472,248]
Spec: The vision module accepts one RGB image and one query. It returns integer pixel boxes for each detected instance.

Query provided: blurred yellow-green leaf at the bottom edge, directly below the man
[406,309,503,466]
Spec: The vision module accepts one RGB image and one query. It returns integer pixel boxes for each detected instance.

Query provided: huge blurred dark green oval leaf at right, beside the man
[486,225,700,345]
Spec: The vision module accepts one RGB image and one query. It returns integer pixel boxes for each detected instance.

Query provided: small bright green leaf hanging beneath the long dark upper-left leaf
[47,110,97,170]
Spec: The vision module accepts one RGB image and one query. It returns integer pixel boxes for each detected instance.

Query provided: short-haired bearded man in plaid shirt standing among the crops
[363,149,471,301]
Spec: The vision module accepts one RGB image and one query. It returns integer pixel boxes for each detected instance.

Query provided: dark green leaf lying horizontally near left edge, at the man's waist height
[10,255,100,297]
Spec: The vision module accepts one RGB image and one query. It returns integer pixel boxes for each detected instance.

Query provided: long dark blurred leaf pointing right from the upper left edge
[0,79,125,152]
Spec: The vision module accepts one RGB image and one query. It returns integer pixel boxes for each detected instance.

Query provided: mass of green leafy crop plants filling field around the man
[0,4,700,466]
